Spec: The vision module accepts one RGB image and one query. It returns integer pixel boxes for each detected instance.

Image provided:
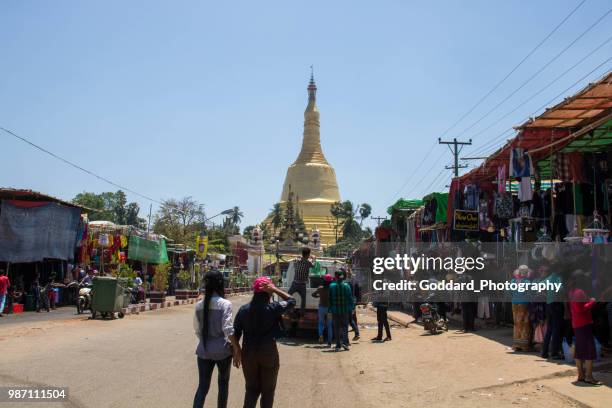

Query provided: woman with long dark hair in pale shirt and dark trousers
[193,271,240,408]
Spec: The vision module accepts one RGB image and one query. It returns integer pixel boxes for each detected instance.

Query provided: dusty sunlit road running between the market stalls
[0,298,612,408]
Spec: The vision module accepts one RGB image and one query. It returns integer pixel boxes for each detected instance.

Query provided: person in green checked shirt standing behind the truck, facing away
[329,269,354,351]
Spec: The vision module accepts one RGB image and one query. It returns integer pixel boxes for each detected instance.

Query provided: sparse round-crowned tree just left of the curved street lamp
[153,197,206,244]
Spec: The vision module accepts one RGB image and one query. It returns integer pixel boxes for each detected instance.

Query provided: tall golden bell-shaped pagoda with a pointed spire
[280,74,340,245]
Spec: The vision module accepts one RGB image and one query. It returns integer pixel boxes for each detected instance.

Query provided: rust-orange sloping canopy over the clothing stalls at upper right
[454,72,612,184]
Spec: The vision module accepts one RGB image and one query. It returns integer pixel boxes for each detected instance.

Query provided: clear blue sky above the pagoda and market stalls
[0,0,612,226]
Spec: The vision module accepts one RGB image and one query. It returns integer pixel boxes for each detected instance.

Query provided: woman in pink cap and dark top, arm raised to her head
[234,276,295,408]
